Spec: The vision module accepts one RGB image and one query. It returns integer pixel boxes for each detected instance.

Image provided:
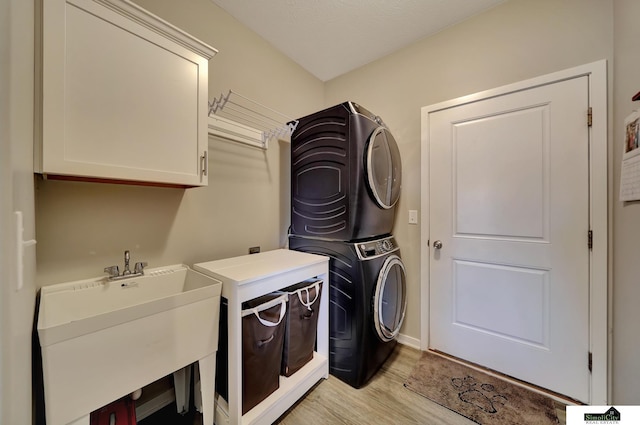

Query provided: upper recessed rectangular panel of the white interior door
[452,106,548,238]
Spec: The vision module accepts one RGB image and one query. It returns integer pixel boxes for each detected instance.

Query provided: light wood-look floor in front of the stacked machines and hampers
[141,345,565,425]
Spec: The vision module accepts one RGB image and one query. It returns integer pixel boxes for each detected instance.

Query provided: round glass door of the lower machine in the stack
[373,255,407,342]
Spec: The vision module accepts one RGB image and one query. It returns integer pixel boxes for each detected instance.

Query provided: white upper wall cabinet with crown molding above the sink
[35,0,216,187]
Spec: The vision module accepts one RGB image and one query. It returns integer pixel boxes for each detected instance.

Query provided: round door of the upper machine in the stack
[366,127,402,209]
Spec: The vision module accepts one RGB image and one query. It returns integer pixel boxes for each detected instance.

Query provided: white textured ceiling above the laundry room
[212,0,505,81]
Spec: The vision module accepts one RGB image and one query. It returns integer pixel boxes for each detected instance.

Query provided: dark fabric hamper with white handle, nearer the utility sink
[242,293,287,415]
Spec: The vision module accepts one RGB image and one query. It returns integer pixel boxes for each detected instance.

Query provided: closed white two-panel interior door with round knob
[428,76,589,402]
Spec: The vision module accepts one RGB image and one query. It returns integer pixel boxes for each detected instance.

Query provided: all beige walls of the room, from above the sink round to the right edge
[31,0,640,404]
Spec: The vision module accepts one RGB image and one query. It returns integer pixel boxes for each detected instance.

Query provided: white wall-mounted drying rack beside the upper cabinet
[209,90,298,149]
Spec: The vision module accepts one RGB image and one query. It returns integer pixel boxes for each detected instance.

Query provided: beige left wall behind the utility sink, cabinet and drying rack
[36,0,324,286]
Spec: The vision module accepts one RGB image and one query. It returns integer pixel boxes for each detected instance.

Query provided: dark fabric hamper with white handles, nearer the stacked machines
[280,279,322,376]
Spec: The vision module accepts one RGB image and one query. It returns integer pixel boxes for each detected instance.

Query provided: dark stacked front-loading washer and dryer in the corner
[289,102,406,388]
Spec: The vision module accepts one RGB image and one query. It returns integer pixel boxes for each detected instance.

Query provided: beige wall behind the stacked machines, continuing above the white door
[325,0,613,352]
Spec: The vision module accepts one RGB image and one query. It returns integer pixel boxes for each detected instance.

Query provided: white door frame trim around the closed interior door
[420,60,610,405]
